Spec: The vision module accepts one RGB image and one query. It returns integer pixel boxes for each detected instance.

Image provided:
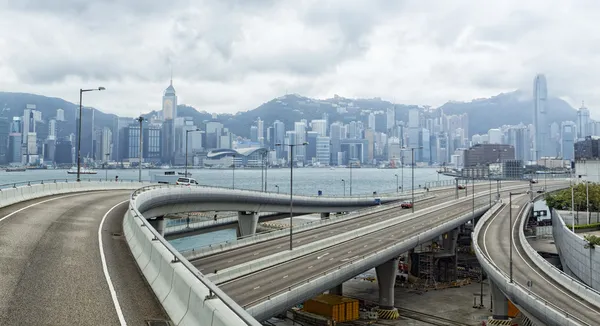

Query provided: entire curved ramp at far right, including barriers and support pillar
[474,190,600,325]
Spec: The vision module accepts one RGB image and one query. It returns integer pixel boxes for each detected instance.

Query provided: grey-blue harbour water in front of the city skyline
[0,168,453,251]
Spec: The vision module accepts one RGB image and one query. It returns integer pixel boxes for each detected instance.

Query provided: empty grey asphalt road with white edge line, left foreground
[0,191,165,325]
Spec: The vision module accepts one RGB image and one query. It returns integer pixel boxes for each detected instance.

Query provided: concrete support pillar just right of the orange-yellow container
[375,258,400,319]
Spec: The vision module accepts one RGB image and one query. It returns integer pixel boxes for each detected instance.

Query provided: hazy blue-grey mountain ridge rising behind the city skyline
[0,90,576,137]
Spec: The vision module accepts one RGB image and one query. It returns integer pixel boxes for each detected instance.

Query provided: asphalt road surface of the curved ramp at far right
[477,195,600,325]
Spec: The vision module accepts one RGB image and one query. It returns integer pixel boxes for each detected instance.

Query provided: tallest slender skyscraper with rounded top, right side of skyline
[533,74,550,160]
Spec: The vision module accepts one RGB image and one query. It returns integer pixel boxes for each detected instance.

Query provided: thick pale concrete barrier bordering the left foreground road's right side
[123,189,260,326]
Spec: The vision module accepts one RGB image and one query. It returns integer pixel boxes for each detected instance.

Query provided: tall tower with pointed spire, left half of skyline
[162,70,177,163]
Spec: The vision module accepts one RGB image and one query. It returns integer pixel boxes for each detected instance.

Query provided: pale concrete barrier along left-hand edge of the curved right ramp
[472,204,586,326]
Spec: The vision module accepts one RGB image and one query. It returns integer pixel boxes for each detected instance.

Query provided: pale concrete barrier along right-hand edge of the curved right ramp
[519,203,600,307]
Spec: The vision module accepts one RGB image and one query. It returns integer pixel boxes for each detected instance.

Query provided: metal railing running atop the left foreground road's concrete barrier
[129,185,260,326]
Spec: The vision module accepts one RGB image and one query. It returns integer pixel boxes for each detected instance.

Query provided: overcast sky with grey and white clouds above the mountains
[0,0,600,118]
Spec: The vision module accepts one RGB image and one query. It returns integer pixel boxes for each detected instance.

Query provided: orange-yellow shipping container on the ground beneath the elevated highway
[303,294,359,322]
